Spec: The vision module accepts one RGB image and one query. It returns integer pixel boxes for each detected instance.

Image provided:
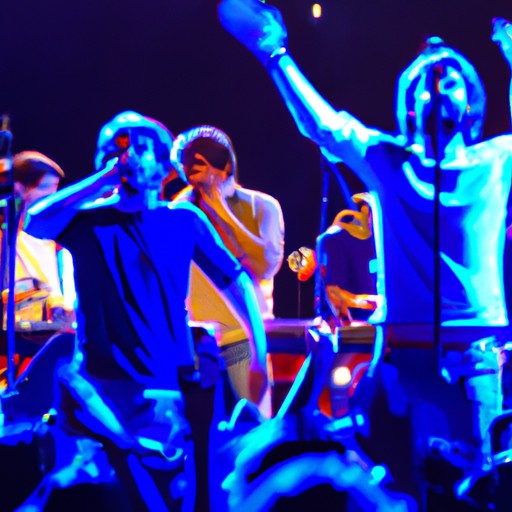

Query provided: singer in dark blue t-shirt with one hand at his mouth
[22,112,267,511]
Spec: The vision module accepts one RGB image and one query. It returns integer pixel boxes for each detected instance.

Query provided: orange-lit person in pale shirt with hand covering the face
[171,126,284,404]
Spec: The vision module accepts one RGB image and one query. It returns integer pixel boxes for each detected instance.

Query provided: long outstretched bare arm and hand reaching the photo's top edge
[218,0,368,166]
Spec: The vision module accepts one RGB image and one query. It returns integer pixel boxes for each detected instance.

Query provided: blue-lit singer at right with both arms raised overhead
[219,0,512,503]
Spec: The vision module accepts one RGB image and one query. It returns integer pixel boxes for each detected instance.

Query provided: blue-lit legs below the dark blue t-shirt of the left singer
[55,367,194,512]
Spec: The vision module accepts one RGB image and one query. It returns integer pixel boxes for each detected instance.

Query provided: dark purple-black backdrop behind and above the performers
[0,0,512,317]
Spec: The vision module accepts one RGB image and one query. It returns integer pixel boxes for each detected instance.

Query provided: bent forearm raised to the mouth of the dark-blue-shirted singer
[24,158,120,240]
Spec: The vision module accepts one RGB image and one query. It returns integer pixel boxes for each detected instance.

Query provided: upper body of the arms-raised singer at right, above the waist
[220,0,512,326]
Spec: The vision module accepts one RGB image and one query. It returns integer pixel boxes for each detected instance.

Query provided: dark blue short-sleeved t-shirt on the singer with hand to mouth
[57,200,241,389]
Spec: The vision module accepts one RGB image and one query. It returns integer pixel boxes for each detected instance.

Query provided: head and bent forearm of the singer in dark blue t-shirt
[25,119,172,239]
